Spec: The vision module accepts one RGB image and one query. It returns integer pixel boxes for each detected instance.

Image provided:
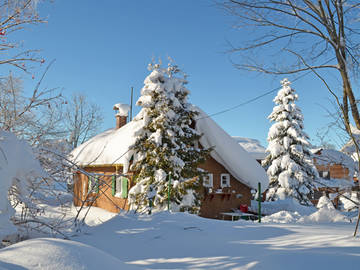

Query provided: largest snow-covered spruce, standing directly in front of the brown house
[129,64,210,212]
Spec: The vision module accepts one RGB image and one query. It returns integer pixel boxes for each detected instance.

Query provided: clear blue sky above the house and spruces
[9,0,344,146]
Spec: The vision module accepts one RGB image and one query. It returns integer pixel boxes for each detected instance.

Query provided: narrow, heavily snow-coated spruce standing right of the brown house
[263,79,318,205]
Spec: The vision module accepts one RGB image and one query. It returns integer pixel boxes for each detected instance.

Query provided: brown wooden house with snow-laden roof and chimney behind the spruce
[70,104,268,218]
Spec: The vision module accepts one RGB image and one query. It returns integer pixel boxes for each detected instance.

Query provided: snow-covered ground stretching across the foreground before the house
[0,208,360,269]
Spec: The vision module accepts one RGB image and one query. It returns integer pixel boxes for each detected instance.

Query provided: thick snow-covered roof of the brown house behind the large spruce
[70,109,269,190]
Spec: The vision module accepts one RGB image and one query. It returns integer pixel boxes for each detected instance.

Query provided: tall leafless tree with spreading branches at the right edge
[221,0,360,235]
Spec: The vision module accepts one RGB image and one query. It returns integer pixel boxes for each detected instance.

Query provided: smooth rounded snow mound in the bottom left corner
[0,238,139,270]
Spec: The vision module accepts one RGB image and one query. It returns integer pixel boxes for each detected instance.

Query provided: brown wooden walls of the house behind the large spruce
[74,157,251,218]
